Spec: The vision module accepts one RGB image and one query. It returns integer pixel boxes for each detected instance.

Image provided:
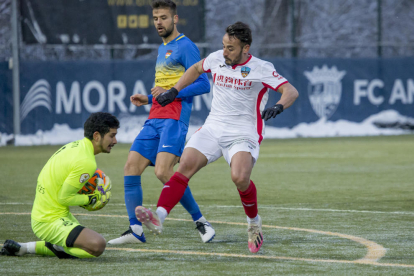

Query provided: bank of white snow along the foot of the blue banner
[0,110,414,146]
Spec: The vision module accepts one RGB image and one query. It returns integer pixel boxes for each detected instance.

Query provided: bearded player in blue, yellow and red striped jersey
[108,0,215,244]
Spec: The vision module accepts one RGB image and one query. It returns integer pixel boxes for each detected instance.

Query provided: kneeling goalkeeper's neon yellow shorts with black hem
[32,213,85,247]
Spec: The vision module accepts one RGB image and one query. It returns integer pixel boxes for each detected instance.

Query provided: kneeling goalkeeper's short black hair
[83,112,119,140]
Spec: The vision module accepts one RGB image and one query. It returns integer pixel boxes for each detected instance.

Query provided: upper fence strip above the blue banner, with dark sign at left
[0,0,414,60]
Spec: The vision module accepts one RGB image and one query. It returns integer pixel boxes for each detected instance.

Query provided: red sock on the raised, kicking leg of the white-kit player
[157,172,189,214]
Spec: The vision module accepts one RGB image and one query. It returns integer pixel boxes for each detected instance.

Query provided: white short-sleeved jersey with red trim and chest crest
[203,50,287,143]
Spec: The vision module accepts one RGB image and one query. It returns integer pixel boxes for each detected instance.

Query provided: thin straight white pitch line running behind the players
[0,202,414,216]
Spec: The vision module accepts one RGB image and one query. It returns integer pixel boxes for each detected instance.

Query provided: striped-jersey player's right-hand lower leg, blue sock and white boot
[180,186,216,242]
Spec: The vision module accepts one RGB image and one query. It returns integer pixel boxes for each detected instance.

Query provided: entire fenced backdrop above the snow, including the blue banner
[0,0,414,140]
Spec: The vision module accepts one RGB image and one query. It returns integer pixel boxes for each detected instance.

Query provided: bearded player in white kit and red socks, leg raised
[135,22,299,253]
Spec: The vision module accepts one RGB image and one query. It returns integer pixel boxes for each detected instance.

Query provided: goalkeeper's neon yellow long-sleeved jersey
[32,138,96,222]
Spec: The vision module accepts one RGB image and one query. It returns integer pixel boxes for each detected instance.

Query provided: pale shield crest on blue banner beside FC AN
[303,65,346,119]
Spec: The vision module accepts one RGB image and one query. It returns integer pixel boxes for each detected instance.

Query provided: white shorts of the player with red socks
[185,123,260,165]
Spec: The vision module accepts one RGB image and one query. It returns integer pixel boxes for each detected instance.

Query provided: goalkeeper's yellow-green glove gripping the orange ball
[81,176,112,211]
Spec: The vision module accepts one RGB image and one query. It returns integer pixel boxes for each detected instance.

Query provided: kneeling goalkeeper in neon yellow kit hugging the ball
[1,112,119,259]
